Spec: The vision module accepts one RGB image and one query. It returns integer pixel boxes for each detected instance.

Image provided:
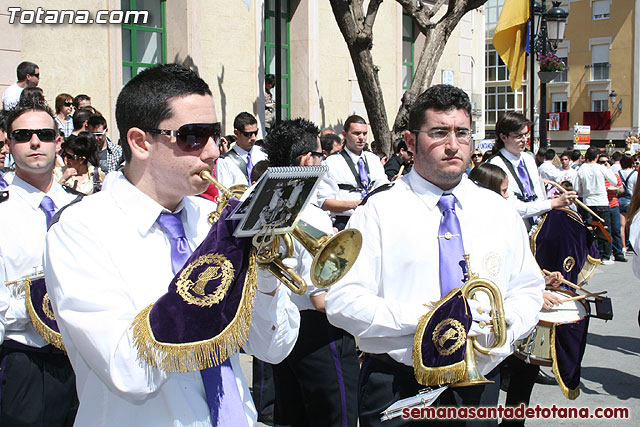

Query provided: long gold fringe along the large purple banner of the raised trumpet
[131,248,258,372]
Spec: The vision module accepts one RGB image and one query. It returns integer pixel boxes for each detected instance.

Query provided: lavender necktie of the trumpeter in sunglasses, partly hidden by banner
[157,211,246,426]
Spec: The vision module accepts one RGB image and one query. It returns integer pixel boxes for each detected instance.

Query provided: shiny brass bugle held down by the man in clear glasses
[450,254,507,387]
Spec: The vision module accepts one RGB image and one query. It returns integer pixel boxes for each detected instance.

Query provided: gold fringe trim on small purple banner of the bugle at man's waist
[412,289,468,386]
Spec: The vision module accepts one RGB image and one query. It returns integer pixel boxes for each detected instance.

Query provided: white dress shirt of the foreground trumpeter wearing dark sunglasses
[45,175,300,426]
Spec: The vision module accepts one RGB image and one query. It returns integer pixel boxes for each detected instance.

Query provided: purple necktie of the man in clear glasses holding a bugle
[438,194,466,296]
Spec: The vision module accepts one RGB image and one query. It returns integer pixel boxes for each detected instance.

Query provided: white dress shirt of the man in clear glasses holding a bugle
[325,169,544,373]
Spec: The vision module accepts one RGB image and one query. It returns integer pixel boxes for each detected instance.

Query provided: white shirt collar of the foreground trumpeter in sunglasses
[110,174,197,241]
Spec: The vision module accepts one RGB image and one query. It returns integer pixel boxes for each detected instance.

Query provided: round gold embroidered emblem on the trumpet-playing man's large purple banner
[176,254,235,307]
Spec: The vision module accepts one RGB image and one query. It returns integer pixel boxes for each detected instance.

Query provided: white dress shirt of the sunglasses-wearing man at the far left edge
[0,176,76,347]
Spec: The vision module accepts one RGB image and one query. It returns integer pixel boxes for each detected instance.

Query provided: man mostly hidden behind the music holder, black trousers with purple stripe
[264,119,360,427]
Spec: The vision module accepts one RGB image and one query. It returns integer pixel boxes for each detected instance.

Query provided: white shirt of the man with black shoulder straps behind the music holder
[318,147,389,216]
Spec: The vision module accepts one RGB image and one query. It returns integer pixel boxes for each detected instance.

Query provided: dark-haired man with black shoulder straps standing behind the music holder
[318,114,389,230]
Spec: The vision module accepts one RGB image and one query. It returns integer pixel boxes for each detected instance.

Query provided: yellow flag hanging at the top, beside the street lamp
[493,0,529,90]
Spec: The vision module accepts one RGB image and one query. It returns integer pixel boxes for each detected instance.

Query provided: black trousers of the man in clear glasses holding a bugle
[358,355,500,427]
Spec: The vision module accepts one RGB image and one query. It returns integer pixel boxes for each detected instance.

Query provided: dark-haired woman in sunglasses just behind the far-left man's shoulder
[59,132,105,194]
